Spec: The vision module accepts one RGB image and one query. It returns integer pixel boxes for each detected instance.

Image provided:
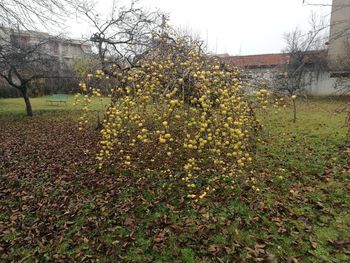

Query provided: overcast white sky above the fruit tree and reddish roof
[67,0,331,55]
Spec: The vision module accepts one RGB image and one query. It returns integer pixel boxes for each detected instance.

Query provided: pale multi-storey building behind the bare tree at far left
[0,27,92,98]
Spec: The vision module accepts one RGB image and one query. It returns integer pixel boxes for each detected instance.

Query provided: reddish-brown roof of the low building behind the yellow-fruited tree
[221,50,327,68]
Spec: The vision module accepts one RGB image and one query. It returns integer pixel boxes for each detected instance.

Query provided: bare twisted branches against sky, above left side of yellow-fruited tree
[78,0,166,74]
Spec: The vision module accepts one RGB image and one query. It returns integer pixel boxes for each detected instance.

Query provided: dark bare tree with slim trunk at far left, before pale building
[0,28,60,116]
